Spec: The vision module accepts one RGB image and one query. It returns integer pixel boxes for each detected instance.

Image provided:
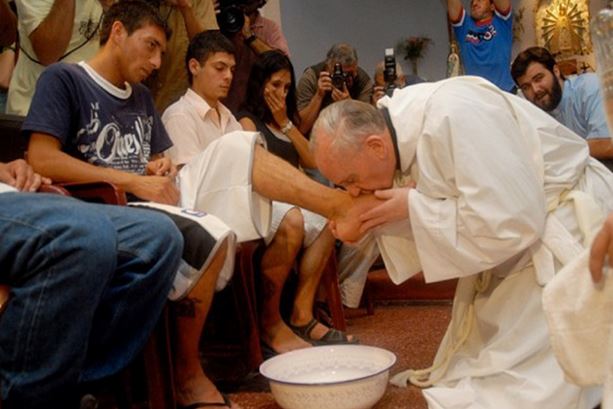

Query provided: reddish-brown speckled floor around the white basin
[225,303,451,409]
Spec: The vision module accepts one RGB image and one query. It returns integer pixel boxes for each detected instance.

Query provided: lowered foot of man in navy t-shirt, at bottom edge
[175,368,241,409]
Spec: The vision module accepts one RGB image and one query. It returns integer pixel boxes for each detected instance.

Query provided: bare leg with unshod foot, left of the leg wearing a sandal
[260,208,311,352]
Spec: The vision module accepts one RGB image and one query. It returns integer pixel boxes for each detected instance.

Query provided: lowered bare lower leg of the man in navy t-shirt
[174,243,240,409]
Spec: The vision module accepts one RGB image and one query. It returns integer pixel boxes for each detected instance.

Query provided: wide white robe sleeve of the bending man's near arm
[409,87,546,282]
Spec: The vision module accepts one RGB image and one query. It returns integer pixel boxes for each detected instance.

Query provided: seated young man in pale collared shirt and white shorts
[162,31,348,352]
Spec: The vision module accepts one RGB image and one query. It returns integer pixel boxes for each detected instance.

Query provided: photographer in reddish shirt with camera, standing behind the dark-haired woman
[216,0,289,114]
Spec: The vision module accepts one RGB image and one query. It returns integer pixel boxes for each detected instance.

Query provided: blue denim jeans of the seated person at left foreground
[0,193,183,409]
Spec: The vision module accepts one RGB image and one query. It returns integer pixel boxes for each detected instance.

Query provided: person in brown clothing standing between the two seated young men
[147,0,219,112]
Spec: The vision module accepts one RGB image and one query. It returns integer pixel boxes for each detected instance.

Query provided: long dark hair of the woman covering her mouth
[242,50,300,125]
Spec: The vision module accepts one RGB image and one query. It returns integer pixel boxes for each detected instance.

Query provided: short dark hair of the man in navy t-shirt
[100,0,171,45]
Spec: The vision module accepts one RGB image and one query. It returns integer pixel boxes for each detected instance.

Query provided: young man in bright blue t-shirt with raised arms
[447,0,516,92]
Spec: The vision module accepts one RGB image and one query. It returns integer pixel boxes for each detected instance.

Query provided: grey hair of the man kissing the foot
[311,99,386,152]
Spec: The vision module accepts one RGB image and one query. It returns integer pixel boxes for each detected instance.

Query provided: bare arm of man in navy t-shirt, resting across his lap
[28,133,179,204]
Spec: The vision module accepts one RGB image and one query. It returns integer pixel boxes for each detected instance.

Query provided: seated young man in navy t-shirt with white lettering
[23,1,238,408]
